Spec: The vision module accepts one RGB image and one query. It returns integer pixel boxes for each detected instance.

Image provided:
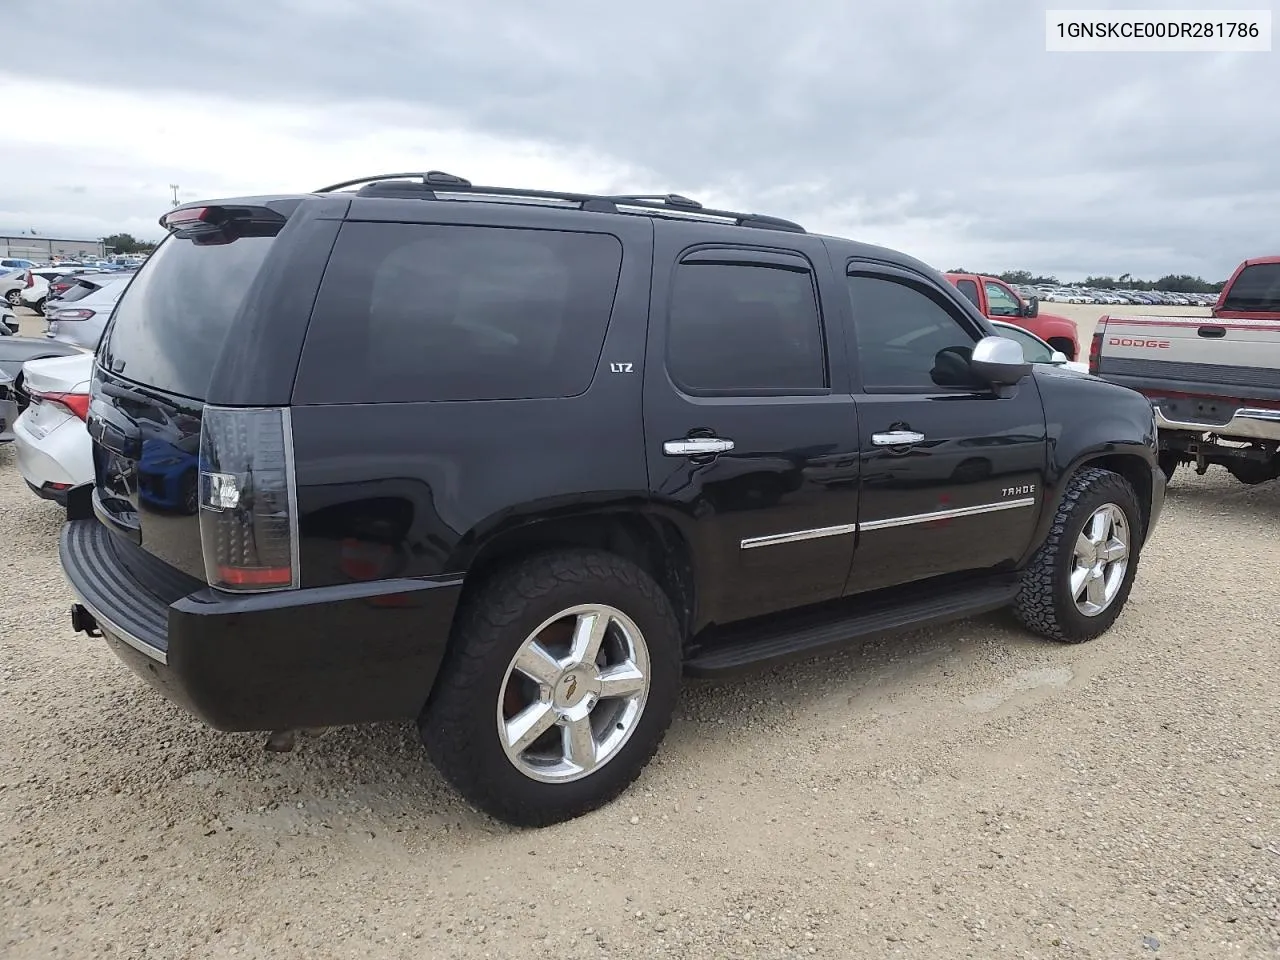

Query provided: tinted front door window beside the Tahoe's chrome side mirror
[849,275,977,393]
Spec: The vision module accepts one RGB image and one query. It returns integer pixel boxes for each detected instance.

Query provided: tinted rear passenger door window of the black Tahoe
[667,262,827,393]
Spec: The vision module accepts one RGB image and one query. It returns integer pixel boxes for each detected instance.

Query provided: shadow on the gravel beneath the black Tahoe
[73,613,1056,837]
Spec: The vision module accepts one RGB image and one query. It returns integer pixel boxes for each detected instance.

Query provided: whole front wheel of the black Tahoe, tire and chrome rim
[1014,467,1143,644]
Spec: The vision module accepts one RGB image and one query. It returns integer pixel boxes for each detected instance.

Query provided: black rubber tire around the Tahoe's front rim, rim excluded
[1014,467,1143,644]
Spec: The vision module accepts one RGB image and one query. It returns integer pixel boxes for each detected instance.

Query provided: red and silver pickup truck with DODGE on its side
[1089,257,1280,484]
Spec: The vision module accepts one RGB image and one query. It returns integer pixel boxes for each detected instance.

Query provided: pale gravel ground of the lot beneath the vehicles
[0,305,1280,960]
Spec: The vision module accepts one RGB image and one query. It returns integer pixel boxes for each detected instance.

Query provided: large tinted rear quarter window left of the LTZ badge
[294,223,622,403]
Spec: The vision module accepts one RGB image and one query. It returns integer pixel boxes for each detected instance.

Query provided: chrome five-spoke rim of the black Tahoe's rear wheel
[498,604,649,783]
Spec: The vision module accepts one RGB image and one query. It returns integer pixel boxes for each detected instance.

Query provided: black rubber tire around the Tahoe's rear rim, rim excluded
[419,549,681,827]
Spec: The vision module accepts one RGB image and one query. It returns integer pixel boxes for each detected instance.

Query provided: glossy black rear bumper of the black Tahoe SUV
[59,520,462,731]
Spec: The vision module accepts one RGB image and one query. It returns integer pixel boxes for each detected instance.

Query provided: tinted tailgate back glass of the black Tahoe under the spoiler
[101,237,273,399]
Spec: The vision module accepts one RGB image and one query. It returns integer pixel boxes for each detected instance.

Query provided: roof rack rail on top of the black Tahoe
[312,170,805,233]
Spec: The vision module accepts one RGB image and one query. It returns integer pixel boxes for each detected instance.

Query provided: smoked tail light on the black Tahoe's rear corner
[200,406,298,591]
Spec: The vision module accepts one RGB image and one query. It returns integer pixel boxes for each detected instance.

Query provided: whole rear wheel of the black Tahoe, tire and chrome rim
[419,550,681,827]
